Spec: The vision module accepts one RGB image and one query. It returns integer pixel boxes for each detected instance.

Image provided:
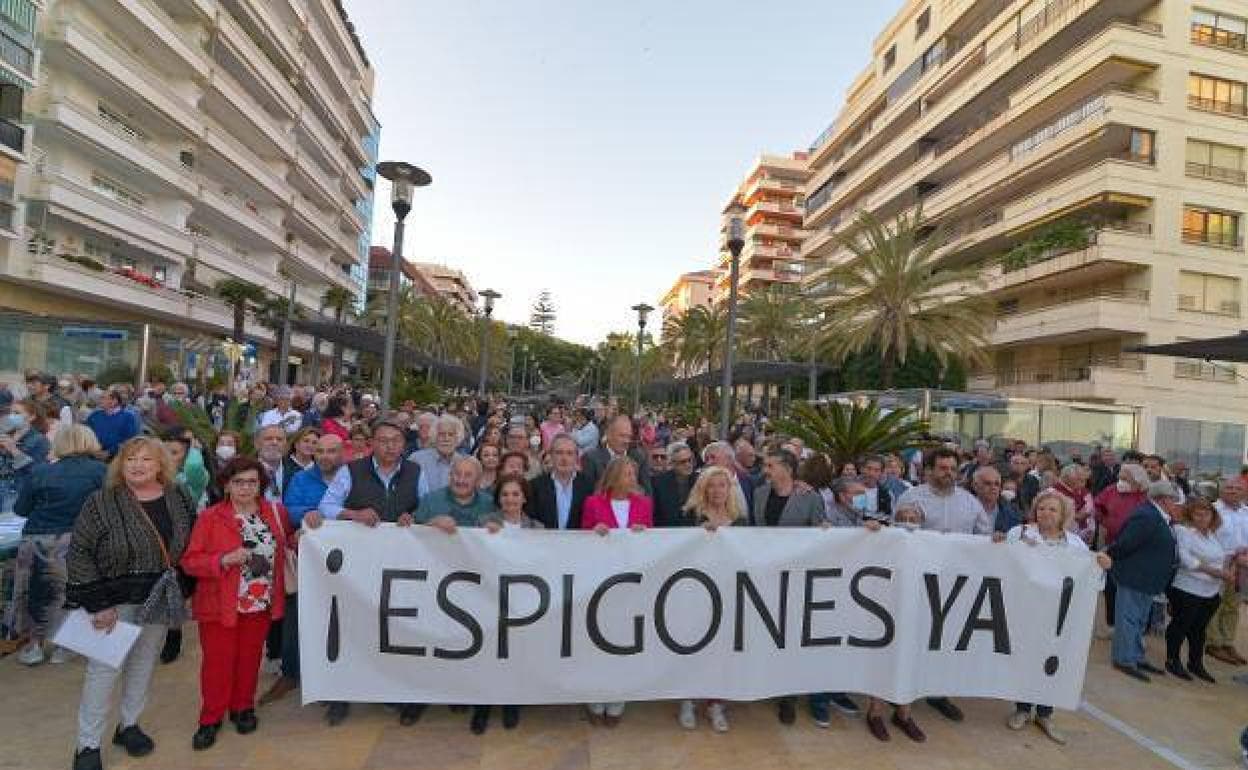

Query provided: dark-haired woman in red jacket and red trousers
[181,457,288,750]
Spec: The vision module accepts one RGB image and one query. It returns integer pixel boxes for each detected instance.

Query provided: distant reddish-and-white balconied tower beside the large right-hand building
[714,152,810,302]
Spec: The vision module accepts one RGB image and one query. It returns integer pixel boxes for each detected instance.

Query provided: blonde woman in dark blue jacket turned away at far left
[14,426,107,665]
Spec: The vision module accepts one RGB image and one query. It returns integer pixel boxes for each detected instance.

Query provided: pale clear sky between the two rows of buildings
[346,0,902,344]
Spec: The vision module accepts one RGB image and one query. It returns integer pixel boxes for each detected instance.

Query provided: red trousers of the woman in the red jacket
[200,612,270,725]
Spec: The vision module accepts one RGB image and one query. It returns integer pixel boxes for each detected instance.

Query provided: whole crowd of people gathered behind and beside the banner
[0,372,1248,770]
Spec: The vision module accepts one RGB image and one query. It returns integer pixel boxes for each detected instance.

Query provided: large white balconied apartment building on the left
[0,0,378,384]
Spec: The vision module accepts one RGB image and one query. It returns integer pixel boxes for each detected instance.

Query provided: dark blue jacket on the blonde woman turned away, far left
[14,454,107,534]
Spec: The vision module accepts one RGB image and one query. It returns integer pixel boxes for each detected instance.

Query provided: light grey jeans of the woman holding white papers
[77,604,166,749]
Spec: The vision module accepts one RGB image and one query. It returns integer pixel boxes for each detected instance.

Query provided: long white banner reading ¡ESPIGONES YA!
[298,522,1102,709]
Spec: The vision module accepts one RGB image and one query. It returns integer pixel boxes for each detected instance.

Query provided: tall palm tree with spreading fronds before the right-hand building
[809,211,991,388]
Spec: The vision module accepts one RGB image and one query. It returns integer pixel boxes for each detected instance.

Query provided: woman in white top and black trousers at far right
[1166,498,1234,684]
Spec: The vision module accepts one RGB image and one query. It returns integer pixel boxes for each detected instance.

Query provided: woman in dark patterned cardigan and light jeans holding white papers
[66,437,195,770]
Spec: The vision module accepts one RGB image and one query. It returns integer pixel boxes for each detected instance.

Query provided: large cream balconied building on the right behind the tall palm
[802,0,1248,472]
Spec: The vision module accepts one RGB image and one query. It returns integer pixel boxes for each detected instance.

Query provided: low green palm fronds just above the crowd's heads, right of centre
[775,399,929,468]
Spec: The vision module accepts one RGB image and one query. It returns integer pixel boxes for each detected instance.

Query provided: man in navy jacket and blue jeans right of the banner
[1107,480,1179,681]
